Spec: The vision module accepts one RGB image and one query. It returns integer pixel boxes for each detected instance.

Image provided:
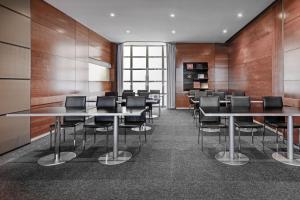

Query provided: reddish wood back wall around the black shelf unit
[176,43,228,108]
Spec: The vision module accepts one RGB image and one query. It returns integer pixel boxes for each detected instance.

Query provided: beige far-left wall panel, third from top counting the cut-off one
[0,43,31,79]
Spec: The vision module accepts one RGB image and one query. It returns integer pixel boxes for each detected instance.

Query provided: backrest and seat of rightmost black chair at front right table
[263,96,285,123]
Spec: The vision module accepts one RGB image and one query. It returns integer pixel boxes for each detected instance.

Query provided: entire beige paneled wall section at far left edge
[0,0,31,154]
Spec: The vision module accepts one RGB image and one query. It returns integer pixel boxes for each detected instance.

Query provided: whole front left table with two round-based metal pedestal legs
[6,106,145,166]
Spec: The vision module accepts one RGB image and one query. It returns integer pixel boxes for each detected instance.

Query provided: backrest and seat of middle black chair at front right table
[231,96,253,122]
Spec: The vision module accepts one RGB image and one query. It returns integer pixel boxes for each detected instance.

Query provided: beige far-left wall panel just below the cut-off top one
[0,6,30,48]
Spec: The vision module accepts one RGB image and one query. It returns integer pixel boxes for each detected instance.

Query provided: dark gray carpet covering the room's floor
[0,110,300,200]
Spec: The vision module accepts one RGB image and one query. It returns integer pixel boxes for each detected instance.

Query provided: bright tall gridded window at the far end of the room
[123,43,167,106]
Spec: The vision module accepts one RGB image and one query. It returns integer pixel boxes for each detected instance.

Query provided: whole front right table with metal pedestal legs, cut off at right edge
[200,104,300,166]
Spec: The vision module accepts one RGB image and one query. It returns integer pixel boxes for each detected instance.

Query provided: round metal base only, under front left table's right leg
[98,151,132,165]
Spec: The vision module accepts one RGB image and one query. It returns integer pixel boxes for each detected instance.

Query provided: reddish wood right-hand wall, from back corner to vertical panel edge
[228,1,282,98]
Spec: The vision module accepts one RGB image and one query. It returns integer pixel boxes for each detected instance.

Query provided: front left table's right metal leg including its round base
[98,116,132,165]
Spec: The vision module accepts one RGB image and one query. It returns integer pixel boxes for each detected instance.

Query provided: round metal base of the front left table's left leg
[38,152,76,167]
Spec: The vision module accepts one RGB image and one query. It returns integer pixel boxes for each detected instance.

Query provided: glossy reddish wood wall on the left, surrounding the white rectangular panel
[31,0,115,137]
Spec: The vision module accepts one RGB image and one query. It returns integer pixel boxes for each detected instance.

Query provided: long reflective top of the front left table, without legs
[6,106,145,117]
